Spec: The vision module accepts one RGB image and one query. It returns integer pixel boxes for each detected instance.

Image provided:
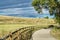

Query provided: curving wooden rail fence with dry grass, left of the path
[0,26,34,40]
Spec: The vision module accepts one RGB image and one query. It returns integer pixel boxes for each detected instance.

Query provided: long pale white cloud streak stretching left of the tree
[0,7,37,14]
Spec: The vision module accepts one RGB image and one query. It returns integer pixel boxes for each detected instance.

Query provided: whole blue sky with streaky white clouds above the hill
[0,0,53,18]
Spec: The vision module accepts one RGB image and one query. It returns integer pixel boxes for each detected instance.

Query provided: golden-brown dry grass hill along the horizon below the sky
[0,16,55,24]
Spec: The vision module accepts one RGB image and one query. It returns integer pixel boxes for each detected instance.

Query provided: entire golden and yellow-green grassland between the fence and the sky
[0,16,56,37]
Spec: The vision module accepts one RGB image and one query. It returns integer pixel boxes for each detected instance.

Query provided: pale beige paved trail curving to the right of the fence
[32,29,56,40]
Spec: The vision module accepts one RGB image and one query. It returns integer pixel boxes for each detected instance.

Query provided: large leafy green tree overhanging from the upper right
[32,0,60,24]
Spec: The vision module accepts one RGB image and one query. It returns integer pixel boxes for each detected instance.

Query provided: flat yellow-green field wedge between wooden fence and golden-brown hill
[0,24,33,37]
